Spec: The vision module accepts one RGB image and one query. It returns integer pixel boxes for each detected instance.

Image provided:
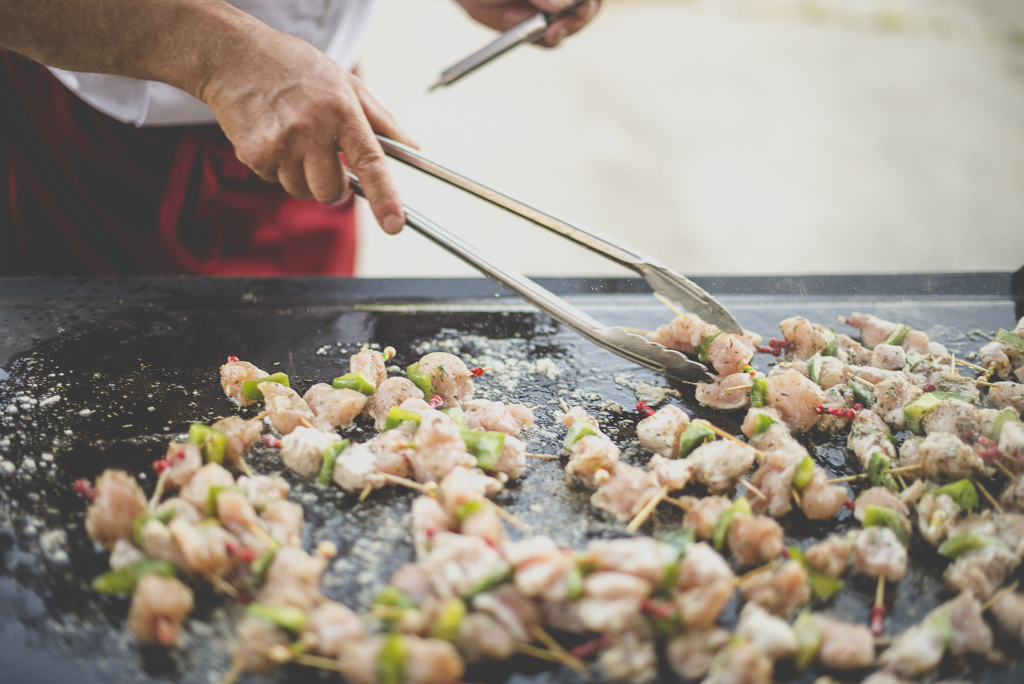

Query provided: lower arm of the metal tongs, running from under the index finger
[345,169,715,382]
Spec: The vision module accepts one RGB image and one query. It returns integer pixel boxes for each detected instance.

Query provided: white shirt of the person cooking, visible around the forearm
[50,0,373,126]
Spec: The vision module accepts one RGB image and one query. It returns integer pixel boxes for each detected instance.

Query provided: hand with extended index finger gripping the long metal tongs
[200,29,418,234]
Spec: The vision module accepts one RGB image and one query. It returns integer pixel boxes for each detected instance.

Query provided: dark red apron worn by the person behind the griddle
[0,49,355,275]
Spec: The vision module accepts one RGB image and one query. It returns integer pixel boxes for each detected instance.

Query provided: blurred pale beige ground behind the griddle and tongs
[357,0,1024,276]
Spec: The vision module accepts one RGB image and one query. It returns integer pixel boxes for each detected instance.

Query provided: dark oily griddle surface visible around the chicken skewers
[0,274,1024,683]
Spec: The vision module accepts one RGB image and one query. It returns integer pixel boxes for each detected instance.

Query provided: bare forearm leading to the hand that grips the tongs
[0,0,269,98]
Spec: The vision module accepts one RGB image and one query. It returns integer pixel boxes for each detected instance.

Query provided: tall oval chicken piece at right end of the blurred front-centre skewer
[672,542,736,627]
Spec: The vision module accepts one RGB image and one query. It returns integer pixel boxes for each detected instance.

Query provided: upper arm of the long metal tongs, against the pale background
[377,135,743,335]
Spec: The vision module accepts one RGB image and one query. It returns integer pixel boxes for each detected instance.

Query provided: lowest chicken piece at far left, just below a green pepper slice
[128,574,195,646]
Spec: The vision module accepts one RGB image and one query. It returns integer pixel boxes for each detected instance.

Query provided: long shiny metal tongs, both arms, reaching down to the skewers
[346,135,742,381]
